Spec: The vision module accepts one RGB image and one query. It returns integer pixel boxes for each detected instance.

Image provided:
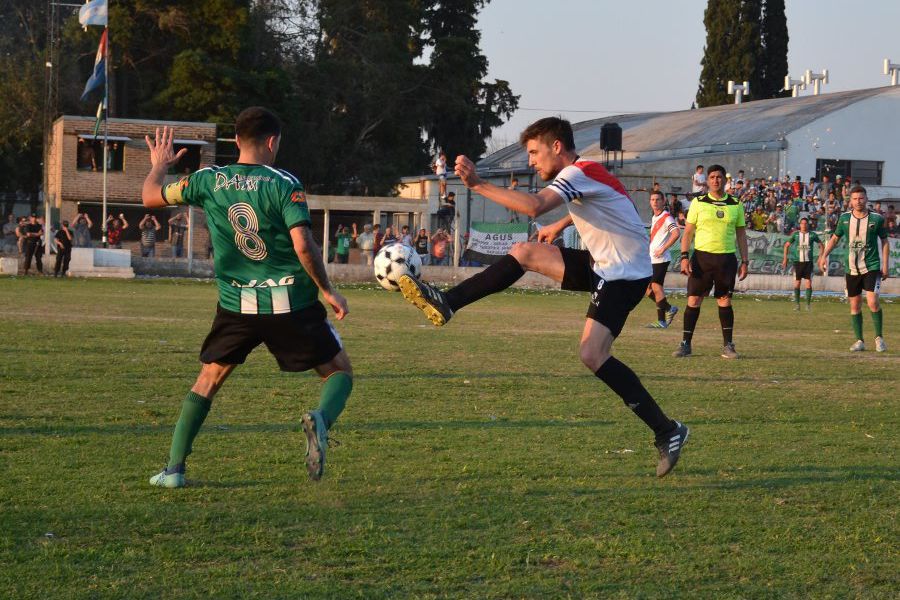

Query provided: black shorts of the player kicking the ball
[560,248,651,337]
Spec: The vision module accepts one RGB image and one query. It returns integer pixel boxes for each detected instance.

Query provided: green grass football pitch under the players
[0,278,900,598]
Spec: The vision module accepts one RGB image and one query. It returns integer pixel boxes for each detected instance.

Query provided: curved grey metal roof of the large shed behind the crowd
[478,86,900,168]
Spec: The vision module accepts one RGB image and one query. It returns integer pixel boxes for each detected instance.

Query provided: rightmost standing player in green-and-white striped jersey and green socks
[819,185,890,352]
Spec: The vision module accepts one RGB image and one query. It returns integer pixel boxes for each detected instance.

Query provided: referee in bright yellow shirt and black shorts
[673,165,749,358]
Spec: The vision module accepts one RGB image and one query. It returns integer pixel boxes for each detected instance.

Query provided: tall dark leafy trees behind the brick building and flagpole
[0,0,519,195]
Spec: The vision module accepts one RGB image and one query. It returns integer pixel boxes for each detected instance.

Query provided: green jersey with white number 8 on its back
[163,163,319,315]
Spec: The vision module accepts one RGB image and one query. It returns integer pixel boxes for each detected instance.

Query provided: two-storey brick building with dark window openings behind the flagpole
[47,115,216,258]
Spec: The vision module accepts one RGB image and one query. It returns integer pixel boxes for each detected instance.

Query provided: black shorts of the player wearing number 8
[200,302,342,371]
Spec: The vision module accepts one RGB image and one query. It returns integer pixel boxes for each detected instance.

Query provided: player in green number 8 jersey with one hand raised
[142,107,353,488]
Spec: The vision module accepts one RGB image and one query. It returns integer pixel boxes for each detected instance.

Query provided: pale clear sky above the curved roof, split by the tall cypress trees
[479,0,900,151]
